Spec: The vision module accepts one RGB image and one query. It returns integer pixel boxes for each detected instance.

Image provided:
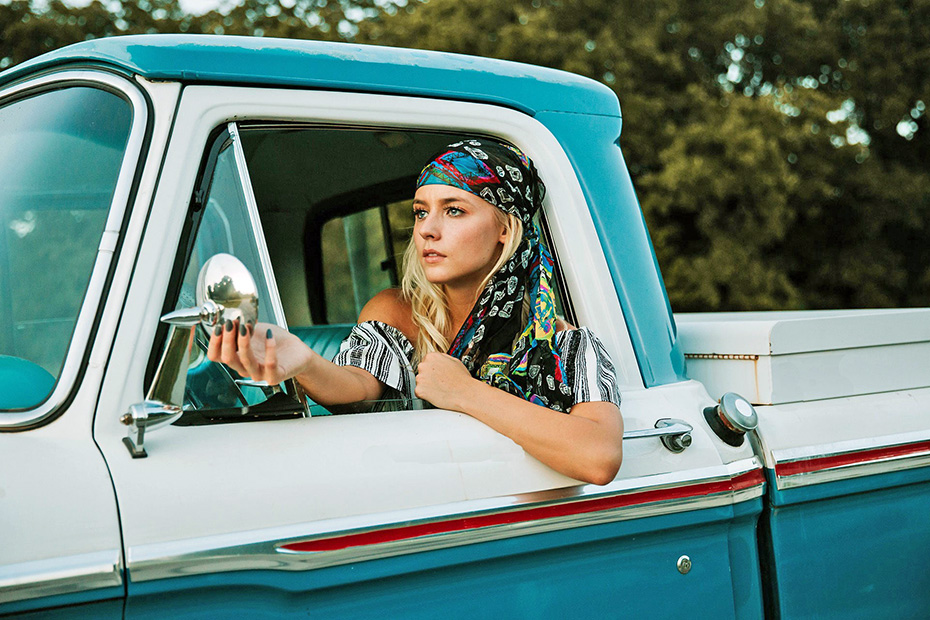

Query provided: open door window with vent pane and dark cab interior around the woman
[167,123,564,424]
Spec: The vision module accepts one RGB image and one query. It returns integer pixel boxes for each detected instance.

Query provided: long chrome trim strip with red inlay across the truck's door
[127,457,764,583]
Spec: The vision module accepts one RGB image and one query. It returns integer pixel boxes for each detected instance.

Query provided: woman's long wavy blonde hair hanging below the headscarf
[401,208,523,365]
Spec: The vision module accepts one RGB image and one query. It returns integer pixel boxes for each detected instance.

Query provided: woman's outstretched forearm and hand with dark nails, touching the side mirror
[207,322,384,406]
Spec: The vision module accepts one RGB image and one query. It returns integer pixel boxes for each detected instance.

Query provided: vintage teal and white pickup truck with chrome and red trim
[0,35,930,618]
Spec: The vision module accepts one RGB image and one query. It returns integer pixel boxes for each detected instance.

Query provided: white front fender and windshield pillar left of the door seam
[0,71,180,601]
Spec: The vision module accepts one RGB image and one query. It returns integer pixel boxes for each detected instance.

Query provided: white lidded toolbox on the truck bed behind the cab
[675,309,930,405]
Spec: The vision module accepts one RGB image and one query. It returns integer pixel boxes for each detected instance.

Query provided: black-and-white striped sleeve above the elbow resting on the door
[556,327,620,407]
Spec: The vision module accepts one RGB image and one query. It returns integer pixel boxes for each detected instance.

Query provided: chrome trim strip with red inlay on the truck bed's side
[772,431,930,490]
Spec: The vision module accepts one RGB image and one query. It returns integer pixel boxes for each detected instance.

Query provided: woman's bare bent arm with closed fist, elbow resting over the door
[416,353,623,484]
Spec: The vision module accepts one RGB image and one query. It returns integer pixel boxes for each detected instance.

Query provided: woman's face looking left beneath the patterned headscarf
[413,185,507,289]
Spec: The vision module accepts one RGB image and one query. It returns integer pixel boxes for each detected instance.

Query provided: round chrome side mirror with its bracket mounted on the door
[120,254,258,458]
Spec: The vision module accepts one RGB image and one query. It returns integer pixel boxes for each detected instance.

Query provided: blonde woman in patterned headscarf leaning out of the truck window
[208,139,623,484]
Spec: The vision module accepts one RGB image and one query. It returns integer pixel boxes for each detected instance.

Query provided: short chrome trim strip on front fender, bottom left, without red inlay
[0,549,123,611]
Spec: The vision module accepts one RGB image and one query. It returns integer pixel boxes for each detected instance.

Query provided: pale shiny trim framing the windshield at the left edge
[0,70,149,432]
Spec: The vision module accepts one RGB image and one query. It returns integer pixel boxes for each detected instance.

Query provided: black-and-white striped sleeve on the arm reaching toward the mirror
[333,321,415,398]
